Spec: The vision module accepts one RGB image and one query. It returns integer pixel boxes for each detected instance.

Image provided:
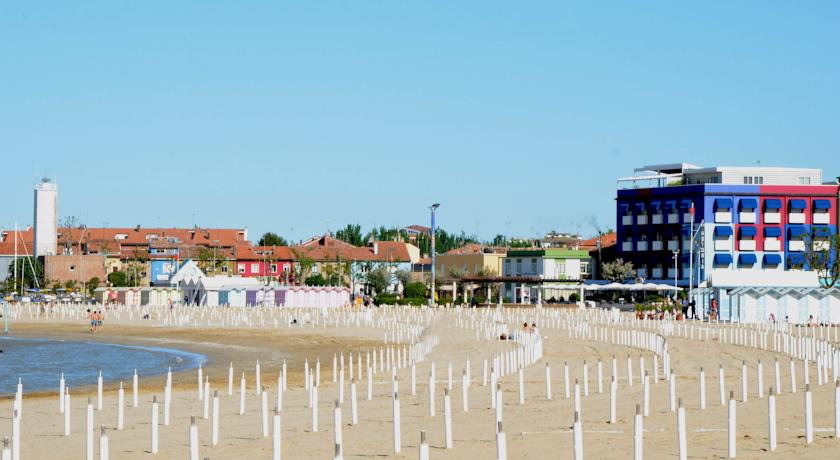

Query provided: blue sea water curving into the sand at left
[0,337,207,395]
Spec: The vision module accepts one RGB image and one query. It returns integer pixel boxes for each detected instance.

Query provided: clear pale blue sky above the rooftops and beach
[0,0,840,240]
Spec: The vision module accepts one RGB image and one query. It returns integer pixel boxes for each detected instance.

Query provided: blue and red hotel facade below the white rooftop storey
[616,184,838,298]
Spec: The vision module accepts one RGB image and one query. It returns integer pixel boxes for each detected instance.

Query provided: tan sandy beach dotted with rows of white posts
[0,309,840,459]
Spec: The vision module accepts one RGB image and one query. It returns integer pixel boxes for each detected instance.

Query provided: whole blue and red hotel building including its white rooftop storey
[616,163,840,287]
